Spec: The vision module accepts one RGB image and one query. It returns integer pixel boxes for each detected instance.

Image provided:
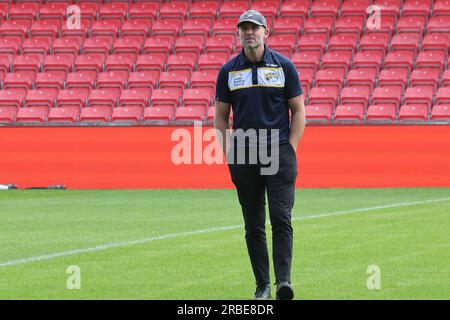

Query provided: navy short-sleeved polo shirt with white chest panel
[216,46,303,144]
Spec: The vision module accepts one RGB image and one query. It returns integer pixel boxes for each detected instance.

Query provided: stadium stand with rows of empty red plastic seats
[0,0,450,125]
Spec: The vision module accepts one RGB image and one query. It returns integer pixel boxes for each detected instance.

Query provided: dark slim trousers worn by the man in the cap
[228,143,297,286]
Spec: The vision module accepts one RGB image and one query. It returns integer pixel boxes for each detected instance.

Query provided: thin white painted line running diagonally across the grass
[0,197,450,267]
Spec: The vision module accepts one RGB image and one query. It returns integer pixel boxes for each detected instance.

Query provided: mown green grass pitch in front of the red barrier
[0,188,450,300]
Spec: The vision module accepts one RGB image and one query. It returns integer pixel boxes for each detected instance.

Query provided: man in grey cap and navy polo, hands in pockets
[214,10,305,300]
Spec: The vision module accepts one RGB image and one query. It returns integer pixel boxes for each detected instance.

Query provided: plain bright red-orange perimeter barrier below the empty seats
[0,126,450,189]
